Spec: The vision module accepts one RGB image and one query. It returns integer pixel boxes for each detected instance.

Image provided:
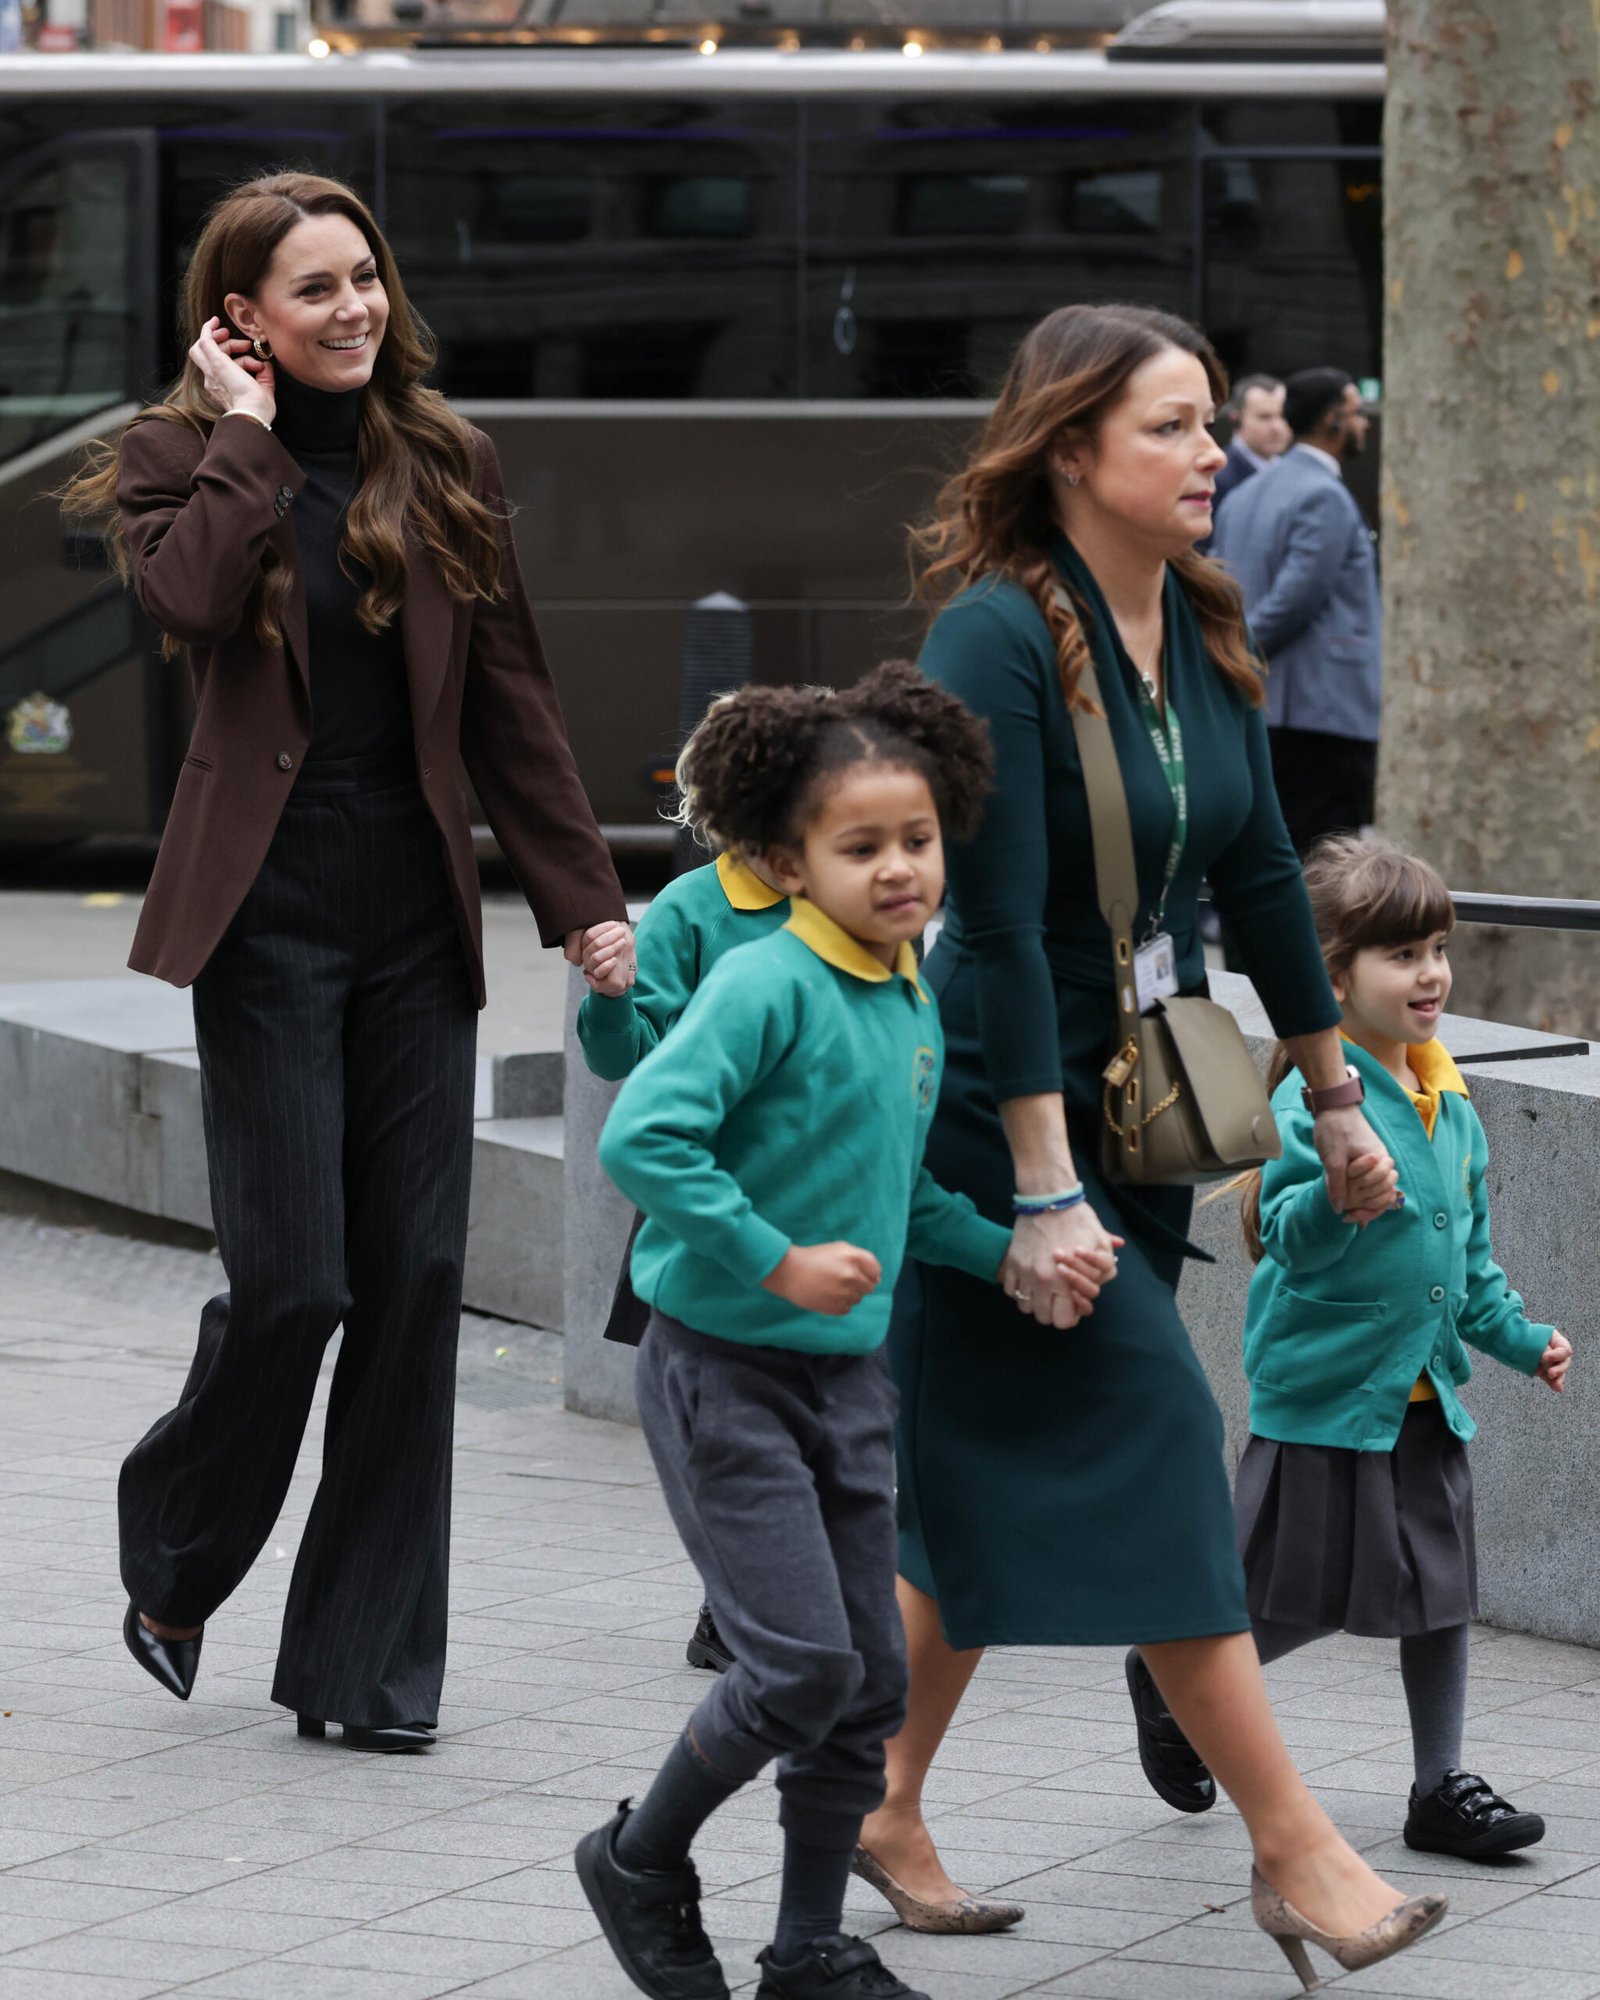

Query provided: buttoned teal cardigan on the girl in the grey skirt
[1244,1044,1550,1452]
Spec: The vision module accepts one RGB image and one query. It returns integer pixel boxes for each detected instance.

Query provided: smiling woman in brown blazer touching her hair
[68,174,624,1750]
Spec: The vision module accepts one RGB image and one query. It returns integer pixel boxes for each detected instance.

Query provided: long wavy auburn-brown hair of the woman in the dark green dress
[910,306,1262,708]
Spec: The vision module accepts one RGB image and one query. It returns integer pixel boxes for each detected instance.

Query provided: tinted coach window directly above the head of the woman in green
[806,98,1192,398]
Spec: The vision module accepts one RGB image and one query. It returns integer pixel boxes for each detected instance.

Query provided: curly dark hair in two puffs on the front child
[680,660,994,852]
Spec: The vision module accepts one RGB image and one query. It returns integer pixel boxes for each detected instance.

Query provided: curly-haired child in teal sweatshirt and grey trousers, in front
[576,666,1048,2000]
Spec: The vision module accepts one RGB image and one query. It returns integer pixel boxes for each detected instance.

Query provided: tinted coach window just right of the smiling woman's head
[388,98,798,398]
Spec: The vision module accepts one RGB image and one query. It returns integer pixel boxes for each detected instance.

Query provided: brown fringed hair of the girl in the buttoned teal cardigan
[1242,834,1456,1264]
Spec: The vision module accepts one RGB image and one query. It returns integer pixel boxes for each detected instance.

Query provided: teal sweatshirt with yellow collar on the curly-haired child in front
[600,898,1010,1354]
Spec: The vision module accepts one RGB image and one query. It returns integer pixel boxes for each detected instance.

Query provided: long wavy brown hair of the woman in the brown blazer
[60,174,500,652]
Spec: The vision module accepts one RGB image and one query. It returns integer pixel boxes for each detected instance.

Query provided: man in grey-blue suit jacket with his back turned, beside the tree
[1210,368,1382,854]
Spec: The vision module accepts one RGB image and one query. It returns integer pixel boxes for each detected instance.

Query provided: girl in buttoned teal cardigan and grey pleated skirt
[1144,836,1572,1860]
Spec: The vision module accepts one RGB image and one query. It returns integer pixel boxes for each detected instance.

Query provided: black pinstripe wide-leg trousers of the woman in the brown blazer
[118,760,478,1728]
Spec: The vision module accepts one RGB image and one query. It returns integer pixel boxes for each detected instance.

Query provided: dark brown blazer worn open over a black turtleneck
[118,416,626,1006]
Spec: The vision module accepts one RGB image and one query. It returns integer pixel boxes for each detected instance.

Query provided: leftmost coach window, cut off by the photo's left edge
[0,146,140,460]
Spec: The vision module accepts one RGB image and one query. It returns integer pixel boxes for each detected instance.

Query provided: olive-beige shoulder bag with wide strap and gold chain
[1070,632,1284,1188]
